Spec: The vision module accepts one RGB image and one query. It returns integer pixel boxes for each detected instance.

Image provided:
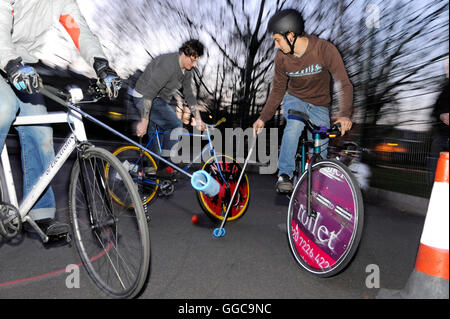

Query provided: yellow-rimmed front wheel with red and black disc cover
[197,155,250,221]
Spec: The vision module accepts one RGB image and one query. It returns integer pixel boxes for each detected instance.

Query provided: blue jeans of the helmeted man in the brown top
[278,94,330,178]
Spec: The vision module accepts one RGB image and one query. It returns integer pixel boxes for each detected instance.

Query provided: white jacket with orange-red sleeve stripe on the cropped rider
[0,0,105,69]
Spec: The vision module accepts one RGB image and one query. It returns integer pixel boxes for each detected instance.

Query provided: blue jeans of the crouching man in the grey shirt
[134,97,183,157]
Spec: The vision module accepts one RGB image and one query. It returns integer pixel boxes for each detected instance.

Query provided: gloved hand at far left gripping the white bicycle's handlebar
[5,57,42,94]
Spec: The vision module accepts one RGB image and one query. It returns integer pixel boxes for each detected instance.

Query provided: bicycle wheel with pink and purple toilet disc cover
[287,160,364,277]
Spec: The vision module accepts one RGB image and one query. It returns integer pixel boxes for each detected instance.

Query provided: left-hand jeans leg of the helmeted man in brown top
[278,94,307,177]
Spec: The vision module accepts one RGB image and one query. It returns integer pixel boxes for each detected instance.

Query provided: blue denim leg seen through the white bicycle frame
[16,95,56,220]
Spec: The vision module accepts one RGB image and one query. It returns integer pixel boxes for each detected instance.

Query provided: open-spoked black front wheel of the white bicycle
[69,147,150,298]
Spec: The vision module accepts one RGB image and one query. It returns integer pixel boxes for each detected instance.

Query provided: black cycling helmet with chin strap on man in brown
[267,9,305,54]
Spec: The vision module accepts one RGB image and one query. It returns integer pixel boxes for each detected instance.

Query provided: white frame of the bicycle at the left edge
[1,110,87,242]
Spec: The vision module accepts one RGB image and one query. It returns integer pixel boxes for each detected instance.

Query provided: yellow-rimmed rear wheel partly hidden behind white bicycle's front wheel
[105,145,159,205]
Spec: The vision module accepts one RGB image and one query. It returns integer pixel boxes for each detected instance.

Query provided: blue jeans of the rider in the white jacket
[0,76,56,220]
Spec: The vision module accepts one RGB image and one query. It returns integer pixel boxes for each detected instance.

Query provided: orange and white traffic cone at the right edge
[377,152,449,299]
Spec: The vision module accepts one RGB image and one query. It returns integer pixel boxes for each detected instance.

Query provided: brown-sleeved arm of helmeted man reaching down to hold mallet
[253,51,289,134]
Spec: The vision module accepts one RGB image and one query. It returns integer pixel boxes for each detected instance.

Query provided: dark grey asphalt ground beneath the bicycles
[0,141,424,300]
